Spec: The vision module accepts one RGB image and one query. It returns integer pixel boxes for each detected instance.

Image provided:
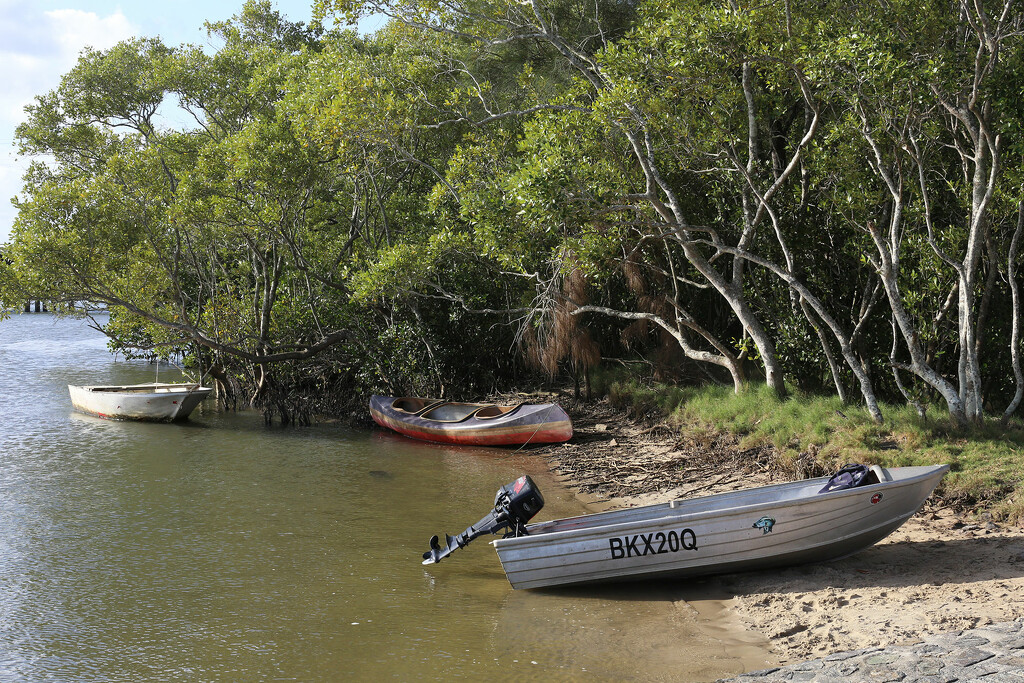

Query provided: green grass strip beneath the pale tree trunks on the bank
[604,374,1024,523]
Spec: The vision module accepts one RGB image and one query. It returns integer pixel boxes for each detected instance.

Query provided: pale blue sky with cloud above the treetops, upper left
[0,0,348,245]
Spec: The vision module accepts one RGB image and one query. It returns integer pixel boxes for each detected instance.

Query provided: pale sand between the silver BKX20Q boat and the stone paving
[720,509,1024,664]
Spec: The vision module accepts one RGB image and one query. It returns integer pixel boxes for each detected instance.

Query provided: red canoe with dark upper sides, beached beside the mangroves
[370,396,572,445]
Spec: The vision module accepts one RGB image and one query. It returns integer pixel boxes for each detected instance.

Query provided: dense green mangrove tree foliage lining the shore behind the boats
[6,0,1024,438]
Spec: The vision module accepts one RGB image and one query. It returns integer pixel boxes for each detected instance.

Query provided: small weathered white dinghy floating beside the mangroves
[68,383,213,422]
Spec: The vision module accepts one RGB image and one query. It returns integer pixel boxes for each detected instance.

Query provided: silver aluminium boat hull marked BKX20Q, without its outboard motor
[494,465,948,589]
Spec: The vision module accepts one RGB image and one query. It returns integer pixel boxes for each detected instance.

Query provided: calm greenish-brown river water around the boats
[0,314,765,681]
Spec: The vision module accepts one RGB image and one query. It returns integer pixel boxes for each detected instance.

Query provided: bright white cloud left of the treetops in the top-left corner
[0,0,139,245]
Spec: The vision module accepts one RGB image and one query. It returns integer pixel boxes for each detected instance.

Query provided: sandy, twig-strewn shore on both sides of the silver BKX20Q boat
[538,401,1024,666]
